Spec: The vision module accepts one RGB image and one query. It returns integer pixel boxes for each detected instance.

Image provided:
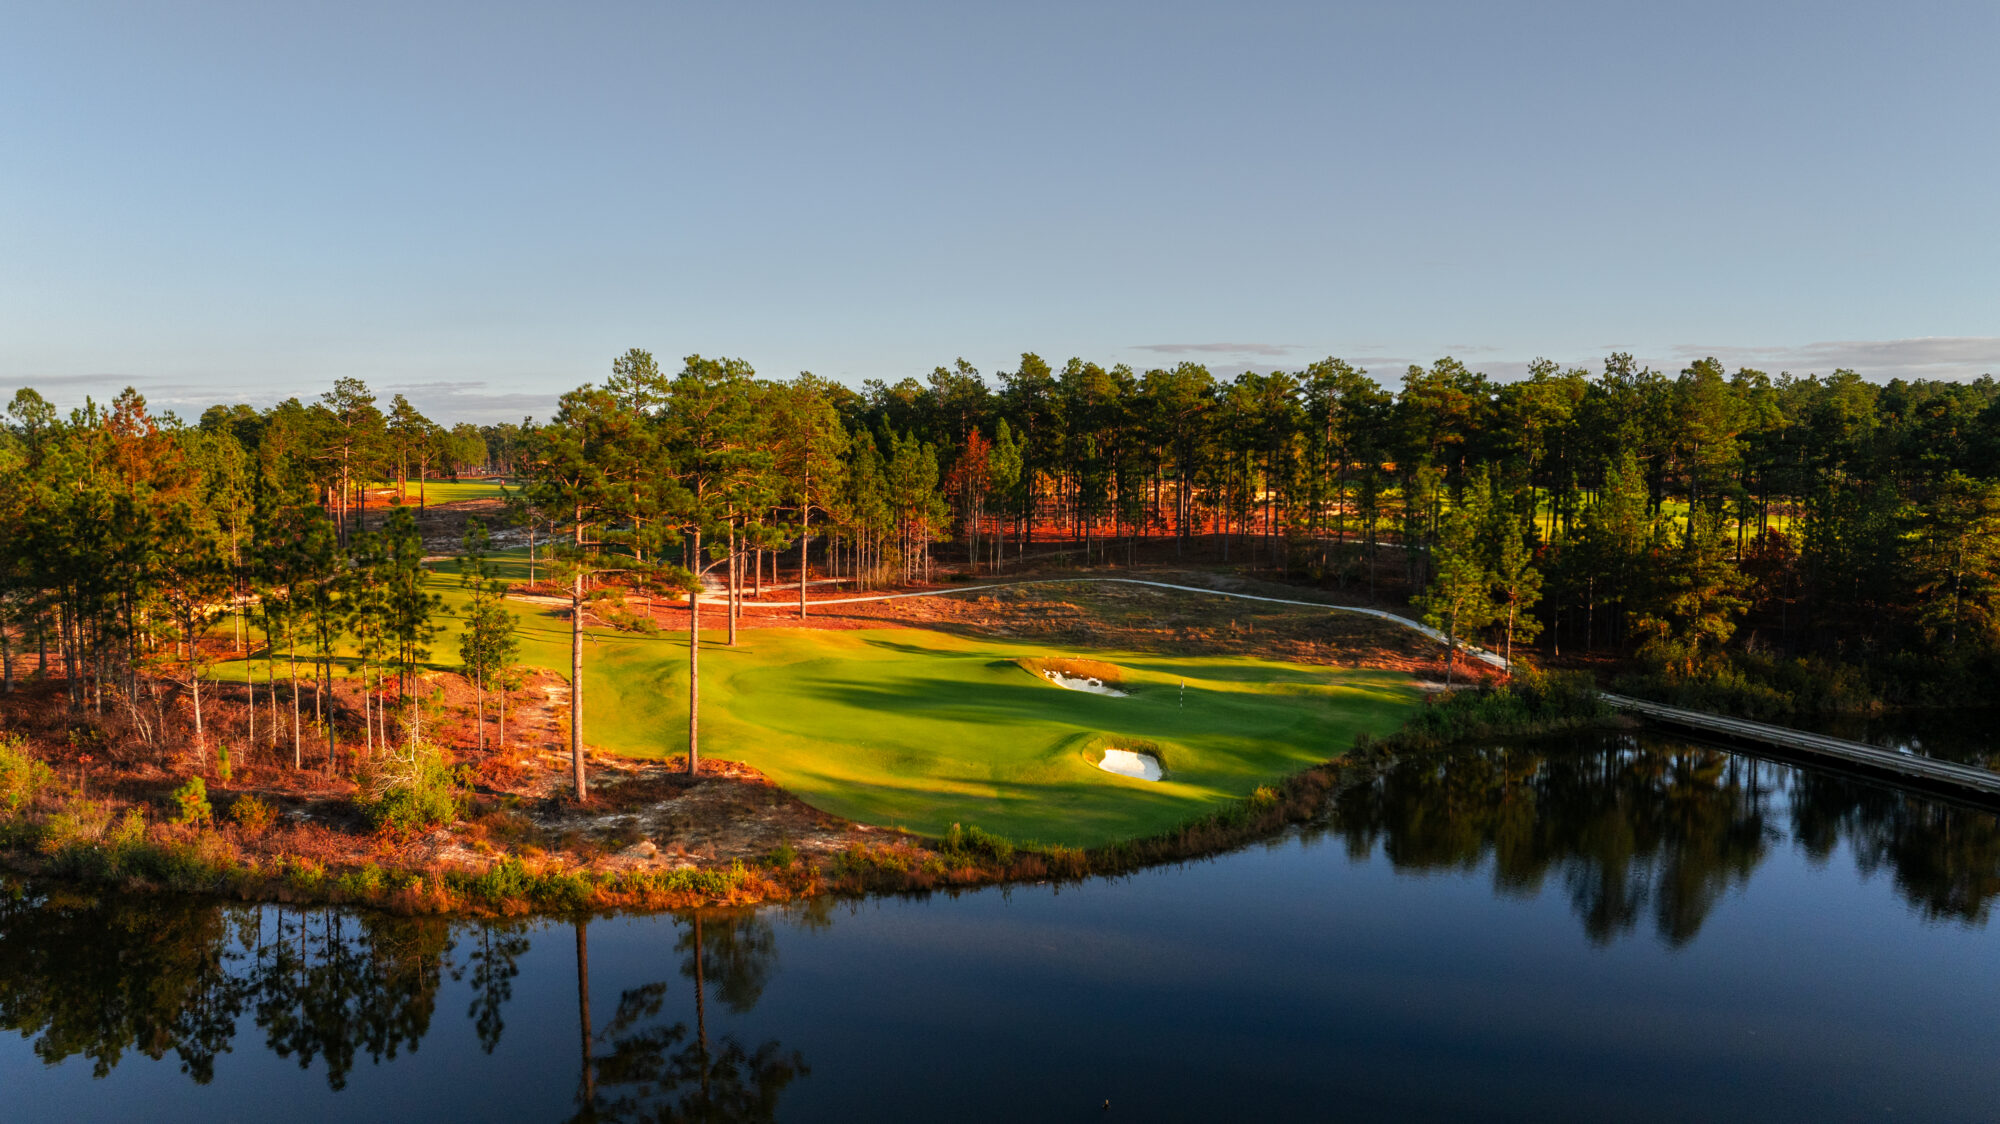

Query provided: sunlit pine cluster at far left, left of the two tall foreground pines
[0,380,518,770]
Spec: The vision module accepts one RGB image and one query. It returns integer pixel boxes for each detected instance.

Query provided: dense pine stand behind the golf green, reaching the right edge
[508,352,2000,710]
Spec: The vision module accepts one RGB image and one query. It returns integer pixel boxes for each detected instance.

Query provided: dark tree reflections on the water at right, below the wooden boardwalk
[1322,734,2000,946]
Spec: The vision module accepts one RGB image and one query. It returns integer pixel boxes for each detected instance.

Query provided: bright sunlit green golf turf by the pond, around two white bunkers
[222,558,1418,846]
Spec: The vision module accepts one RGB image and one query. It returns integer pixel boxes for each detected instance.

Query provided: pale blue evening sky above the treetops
[0,0,2000,422]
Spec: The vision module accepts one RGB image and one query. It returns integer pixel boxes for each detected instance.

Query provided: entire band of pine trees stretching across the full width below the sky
[0,350,2000,788]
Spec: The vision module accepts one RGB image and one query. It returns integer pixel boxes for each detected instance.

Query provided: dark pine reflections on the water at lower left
[0,886,808,1120]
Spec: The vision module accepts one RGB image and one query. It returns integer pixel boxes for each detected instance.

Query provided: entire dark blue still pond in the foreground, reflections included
[0,734,2000,1122]
